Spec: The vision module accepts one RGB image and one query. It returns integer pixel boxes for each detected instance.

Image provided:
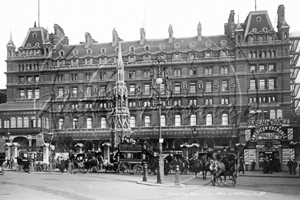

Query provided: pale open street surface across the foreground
[0,170,300,200]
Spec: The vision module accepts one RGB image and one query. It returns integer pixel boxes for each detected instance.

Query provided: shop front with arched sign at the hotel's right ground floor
[240,120,295,172]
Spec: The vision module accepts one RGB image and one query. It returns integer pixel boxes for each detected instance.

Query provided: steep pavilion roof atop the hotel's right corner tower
[244,10,274,38]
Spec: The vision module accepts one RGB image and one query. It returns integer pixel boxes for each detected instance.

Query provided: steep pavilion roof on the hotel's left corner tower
[21,27,47,48]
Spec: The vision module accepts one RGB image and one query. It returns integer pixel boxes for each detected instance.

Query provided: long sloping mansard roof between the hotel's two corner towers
[53,35,234,58]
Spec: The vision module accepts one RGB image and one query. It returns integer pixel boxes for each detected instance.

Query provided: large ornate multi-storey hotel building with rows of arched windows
[0,5,300,169]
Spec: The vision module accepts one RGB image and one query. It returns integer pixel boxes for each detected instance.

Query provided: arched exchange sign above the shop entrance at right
[251,126,287,140]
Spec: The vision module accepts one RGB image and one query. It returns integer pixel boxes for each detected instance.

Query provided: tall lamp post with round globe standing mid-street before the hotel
[151,57,166,183]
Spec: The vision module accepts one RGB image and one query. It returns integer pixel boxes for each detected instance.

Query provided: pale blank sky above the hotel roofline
[0,0,300,89]
